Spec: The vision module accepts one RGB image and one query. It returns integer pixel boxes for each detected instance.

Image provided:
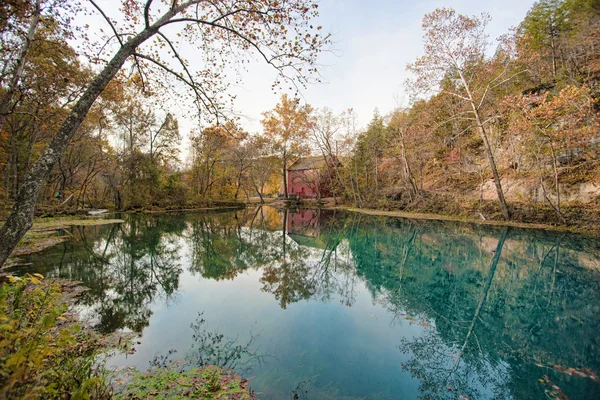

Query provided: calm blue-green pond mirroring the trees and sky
[12,207,600,399]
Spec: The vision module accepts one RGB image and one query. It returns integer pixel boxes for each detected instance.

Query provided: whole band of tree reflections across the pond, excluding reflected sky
[21,207,600,399]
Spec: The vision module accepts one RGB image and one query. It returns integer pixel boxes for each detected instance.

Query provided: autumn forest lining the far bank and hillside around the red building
[0,0,600,260]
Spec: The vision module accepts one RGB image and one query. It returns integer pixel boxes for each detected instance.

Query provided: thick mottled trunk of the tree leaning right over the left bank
[0,25,164,267]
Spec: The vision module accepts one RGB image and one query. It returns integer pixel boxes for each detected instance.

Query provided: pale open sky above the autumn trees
[79,0,533,155]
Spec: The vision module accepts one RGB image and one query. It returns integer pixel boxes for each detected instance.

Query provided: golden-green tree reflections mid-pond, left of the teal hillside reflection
[189,208,354,308]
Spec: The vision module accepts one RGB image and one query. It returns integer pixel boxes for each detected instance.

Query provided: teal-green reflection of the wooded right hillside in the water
[350,222,600,399]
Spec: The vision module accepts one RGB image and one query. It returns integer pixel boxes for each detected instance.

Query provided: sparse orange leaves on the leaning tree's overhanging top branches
[88,0,330,106]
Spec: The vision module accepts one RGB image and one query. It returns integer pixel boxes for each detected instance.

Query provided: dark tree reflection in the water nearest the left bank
[22,215,186,333]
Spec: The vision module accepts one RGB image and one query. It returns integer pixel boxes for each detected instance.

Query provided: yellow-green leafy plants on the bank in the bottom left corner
[0,274,109,399]
